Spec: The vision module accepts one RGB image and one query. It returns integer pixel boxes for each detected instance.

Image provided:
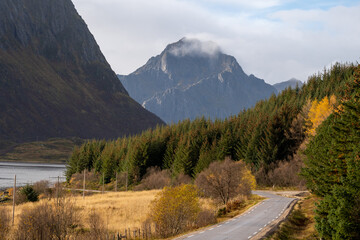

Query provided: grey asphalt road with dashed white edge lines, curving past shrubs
[177,191,294,240]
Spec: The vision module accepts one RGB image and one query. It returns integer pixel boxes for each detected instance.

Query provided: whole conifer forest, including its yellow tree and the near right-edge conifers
[66,64,360,239]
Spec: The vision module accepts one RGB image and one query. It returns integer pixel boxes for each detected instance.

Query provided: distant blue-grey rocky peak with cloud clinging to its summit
[118,38,276,123]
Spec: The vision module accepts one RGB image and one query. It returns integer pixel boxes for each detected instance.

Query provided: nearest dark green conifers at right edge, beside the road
[302,66,360,239]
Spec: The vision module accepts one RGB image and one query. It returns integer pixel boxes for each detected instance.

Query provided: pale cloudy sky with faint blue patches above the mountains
[73,0,360,84]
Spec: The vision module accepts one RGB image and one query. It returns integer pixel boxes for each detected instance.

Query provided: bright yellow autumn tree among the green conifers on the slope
[306,95,336,136]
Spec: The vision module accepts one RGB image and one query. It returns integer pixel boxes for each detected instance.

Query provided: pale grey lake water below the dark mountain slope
[0,162,66,189]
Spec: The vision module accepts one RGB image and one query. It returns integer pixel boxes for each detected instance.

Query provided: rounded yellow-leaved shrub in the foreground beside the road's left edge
[150,185,200,238]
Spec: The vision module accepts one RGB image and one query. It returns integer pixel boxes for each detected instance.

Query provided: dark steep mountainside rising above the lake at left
[0,0,163,142]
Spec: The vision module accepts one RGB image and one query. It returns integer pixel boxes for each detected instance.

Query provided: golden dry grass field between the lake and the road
[0,190,261,239]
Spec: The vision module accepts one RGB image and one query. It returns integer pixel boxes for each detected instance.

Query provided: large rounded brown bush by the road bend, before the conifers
[195,158,255,204]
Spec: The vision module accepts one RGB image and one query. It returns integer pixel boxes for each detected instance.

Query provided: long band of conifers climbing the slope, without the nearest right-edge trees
[66,64,356,188]
